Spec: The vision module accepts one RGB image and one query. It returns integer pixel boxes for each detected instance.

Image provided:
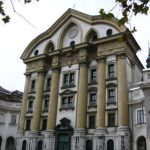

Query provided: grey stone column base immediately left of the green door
[44,130,55,150]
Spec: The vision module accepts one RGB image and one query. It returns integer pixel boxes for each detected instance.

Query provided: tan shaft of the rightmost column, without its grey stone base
[117,54,128,127]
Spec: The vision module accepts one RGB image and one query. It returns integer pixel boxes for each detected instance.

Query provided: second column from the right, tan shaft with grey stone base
[94,57,106,149]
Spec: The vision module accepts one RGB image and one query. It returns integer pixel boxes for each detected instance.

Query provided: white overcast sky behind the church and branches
[0,0,150,91]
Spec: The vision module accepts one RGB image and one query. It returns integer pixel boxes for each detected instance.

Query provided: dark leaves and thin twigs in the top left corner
[0,0,39,23]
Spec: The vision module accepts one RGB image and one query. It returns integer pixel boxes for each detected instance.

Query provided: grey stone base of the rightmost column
[116,126,131,150]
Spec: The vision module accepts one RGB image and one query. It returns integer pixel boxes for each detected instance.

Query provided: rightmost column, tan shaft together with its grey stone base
[116,53,131,150]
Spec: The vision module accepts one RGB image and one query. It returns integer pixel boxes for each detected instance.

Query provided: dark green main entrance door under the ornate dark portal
[57,134,70,150]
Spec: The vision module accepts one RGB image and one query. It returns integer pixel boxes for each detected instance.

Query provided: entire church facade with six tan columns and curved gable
[17,9,144,150]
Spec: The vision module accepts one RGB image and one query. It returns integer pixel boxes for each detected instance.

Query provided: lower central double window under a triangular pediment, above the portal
[61,96,74,109]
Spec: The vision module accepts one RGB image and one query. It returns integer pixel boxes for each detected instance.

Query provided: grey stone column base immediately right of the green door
[71,129,86,150]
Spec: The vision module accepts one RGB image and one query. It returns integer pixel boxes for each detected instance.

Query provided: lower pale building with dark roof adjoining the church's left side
[0,86,23,150]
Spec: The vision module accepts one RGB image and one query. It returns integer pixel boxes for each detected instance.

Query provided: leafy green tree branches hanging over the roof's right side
[100,0,150,32]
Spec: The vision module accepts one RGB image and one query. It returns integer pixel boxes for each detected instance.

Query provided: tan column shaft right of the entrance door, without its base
[76,64,88,129]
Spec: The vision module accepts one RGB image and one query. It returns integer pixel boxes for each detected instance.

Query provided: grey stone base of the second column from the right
[93,128,106,150]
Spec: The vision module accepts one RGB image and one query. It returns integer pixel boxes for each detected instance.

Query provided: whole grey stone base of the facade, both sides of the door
[17,127,131,150]
